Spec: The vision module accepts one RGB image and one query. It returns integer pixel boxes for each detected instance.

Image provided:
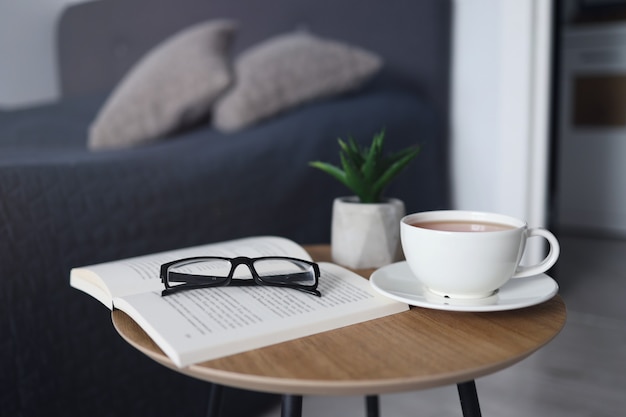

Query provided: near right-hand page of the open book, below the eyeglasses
[114,263,408,366]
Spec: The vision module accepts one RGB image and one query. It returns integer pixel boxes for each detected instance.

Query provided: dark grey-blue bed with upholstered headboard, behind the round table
[0,0,451,417]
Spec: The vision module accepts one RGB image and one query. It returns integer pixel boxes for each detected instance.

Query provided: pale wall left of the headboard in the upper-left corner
[0,0,91,108]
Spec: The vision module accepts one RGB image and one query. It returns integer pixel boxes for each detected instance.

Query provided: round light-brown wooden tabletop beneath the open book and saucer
[112,245,566,395]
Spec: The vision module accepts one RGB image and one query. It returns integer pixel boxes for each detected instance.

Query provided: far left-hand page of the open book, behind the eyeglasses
[70,236,311,308]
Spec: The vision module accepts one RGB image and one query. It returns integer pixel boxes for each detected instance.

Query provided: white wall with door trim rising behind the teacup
[451,0,551,231]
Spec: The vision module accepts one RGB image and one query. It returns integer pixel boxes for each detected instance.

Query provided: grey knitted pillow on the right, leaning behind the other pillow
[212,32,382,131]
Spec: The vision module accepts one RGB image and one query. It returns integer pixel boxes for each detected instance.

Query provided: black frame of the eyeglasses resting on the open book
[160,256,322,297]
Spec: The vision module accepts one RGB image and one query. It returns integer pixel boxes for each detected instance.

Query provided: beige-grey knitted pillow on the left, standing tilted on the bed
[88,20,236,150]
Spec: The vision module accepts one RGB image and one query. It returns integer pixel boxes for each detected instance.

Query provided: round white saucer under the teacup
[370,262,559,311]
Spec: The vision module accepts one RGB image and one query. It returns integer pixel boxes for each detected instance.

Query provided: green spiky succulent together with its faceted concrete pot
[309,130,420,269]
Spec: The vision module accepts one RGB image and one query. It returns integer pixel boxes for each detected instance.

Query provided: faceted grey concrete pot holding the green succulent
[331,197,405,269]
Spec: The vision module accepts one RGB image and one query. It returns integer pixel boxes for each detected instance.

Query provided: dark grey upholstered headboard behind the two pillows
[57,0,452,111]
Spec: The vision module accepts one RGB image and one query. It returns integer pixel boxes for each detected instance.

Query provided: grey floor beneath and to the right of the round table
[263,233,626,417]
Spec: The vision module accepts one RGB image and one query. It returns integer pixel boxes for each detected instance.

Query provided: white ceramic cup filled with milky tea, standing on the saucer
[400,210,560,298]
